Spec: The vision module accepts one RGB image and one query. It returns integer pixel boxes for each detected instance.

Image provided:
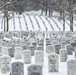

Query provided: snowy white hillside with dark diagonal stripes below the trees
[0,13,76,31]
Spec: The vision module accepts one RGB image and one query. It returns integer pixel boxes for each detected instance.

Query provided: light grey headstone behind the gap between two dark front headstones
[23,50,31,64]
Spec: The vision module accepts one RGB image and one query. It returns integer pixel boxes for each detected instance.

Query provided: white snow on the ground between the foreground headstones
[0,36,75,75]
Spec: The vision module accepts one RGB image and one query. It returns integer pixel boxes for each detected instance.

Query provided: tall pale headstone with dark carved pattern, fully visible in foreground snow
[48,53,59,72]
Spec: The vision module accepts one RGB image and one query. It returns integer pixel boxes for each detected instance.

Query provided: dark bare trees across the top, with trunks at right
[0,0,76,31]
